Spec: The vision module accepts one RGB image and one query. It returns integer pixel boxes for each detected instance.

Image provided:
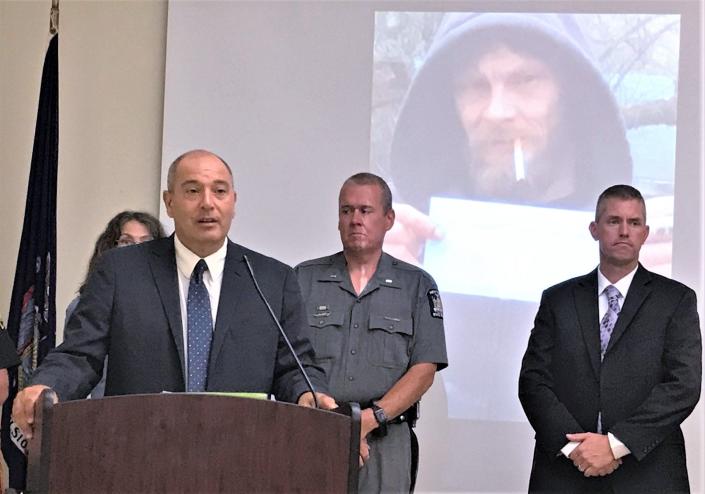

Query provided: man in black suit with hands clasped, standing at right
[519,185,702,493]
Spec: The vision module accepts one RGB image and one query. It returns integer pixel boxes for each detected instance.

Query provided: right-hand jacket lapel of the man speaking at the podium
[208,240,246,375]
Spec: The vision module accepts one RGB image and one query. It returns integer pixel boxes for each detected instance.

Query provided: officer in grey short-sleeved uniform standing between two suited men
[296,173,448,492]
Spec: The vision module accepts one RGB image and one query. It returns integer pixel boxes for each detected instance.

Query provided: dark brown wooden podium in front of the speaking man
[27,391,360,493]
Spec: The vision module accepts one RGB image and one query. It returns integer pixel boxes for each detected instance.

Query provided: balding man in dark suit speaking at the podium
[13,150,335,437]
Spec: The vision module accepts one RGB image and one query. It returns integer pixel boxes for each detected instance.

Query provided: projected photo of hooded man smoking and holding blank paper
[371,12,680,421]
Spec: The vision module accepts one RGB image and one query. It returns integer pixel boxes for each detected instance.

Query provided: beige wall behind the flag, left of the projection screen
[0,0,167,334]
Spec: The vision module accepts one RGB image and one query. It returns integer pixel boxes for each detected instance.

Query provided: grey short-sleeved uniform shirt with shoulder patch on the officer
[296,252,448,403]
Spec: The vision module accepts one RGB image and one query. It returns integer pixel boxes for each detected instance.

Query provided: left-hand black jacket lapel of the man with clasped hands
[573,270,600,379]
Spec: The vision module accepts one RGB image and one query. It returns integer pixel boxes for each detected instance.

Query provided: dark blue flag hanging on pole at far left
[2,34,59,490]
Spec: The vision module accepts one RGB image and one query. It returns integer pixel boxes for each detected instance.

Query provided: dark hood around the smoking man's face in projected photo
[390,13,632,211]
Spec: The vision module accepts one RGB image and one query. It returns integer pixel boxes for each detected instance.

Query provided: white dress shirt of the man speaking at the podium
[174,234,228,379]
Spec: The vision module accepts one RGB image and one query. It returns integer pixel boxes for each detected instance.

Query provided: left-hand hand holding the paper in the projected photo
[384,204,443,265]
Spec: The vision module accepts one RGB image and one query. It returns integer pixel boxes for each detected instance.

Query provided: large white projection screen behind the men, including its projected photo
[162,0,704,492]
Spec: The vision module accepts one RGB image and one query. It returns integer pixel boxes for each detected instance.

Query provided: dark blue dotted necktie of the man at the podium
[186,259,213,392]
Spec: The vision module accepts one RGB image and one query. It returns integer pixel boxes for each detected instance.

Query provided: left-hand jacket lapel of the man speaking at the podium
[149,235,185,373]
